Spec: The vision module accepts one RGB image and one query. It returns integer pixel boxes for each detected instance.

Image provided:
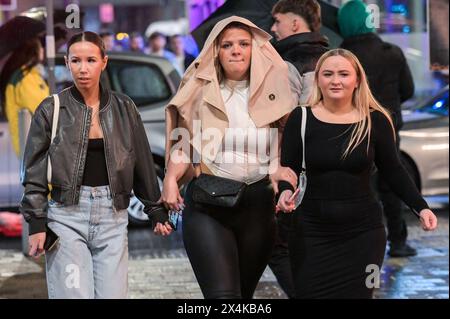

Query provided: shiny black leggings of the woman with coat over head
[183,179,276,299]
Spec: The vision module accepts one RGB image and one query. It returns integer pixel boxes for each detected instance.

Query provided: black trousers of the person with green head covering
[378,132,408,244]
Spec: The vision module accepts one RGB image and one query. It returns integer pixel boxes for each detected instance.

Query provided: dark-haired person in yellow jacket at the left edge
[0,37,50,156]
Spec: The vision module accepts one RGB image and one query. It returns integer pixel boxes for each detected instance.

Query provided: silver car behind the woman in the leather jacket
[0,53,180,225]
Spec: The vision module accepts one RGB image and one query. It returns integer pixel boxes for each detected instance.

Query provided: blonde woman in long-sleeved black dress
[278,49,437,298]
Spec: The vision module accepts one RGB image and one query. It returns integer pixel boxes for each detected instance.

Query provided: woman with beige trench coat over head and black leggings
[162,16,296,298]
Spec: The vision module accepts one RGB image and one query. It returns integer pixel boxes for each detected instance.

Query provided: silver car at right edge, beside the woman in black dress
[400,85,449,198]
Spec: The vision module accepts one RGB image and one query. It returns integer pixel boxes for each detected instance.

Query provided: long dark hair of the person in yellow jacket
[0,38,42,109]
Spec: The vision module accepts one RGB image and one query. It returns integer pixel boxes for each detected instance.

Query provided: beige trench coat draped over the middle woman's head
[166,16,296,172]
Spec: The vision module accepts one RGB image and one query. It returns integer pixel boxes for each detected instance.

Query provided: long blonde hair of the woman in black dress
[308,49,395,158]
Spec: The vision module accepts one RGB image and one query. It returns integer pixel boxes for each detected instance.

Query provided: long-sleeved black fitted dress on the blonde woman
[279,108,428,298]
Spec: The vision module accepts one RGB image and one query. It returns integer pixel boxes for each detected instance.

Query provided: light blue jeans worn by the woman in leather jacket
[46,186,128,299]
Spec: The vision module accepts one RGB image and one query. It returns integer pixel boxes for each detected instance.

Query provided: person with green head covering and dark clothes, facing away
[338,0,417,257]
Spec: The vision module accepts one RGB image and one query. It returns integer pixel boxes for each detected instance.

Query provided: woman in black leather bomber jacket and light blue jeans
[20,32,171,298]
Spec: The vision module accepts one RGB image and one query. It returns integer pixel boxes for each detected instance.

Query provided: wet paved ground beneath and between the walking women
[0,206,449,299]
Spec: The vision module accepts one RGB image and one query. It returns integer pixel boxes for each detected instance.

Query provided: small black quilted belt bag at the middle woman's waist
[192,173,247,207]
